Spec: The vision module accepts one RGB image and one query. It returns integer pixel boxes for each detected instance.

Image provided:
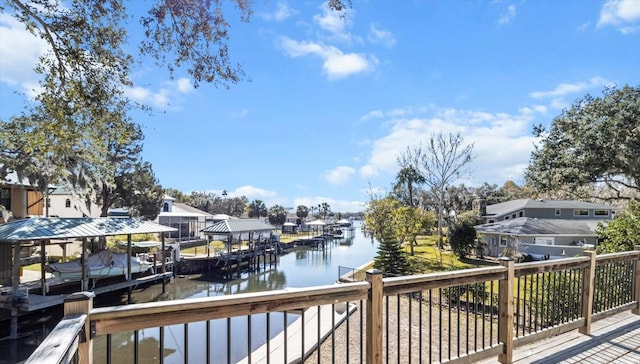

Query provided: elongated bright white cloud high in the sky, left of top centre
[280,37,378,79]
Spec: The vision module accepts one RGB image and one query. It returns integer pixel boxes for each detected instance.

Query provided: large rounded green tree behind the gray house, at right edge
[525,86,640,199]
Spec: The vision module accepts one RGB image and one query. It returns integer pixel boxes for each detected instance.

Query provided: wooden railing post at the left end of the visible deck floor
[498,258,515,364]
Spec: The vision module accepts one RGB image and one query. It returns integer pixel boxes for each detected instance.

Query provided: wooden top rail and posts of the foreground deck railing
[27,247,640,363]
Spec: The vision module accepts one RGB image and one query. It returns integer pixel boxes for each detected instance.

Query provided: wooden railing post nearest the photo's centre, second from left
[366,269,383,364]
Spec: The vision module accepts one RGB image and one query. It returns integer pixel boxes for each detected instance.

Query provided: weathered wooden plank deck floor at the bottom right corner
[482,311,640,364]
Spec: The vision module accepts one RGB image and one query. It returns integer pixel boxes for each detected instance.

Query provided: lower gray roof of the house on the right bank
[475,217,598,236]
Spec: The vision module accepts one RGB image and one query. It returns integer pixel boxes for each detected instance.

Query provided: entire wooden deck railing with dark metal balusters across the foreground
[28,247,640,363]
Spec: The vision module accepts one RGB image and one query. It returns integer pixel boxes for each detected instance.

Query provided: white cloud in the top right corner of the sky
[597,0,640,34]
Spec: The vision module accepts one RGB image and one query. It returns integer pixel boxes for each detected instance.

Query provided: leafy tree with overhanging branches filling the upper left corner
[0,0,350,213]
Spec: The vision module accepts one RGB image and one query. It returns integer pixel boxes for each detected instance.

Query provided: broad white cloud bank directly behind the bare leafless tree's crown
[359,107,539,184]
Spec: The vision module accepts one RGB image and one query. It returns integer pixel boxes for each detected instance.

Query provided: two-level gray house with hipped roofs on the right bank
[474,199,615,259]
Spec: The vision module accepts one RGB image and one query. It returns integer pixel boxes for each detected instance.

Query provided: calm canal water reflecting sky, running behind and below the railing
[0,222,377,364]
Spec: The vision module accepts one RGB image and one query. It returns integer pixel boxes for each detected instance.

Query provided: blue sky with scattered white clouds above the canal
[0,0,640,212]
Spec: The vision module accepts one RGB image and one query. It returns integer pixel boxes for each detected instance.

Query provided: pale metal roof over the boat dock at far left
[0,217,177,243]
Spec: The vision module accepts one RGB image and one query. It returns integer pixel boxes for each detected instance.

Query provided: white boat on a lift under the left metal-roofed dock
[45,250,152,280]
